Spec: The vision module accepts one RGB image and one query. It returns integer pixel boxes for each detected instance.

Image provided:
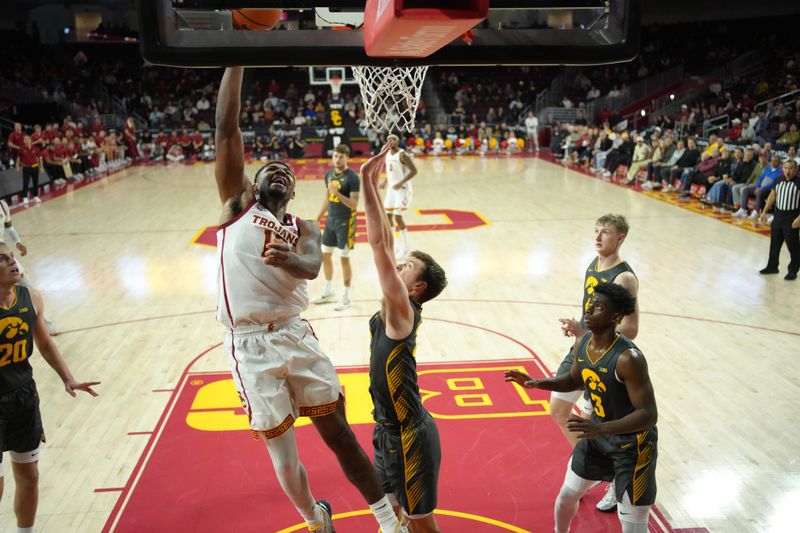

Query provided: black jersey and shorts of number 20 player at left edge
[0,285,44,461]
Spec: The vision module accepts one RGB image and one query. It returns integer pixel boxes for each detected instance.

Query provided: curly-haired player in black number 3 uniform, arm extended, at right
[506,283,658,533]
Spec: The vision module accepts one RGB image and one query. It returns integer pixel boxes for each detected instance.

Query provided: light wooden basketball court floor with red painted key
[0,152,800,532]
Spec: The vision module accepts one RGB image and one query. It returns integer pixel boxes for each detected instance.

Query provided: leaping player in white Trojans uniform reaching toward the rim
[215,67,405,533]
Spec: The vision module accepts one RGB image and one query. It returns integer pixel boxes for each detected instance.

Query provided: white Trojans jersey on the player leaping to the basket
[217,201,308,328]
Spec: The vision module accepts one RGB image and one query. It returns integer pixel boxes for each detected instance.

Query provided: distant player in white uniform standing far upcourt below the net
[380,135,417,259]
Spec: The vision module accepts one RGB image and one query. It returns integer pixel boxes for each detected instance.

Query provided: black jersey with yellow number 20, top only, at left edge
[0,285,36,394]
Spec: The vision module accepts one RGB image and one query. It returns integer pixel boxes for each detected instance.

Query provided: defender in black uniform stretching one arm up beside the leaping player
[361,143,447,532]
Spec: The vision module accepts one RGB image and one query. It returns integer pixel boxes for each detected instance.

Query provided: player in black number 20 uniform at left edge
[0,242,100,533]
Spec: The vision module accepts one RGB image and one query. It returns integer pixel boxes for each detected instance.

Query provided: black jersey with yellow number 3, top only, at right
[575,333,638,423]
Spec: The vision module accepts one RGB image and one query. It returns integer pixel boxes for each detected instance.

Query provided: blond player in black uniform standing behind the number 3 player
[550,214,639,512]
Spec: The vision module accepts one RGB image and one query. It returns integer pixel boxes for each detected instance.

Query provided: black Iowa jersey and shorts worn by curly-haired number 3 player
[572,333,658,506]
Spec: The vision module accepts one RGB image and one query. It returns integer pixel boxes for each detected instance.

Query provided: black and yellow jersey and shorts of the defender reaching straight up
[369,301,442,516]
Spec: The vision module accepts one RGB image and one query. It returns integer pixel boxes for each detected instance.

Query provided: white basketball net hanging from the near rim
[353,66,428,132]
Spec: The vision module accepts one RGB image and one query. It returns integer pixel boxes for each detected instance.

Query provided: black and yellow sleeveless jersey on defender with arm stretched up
[369,300,425,426]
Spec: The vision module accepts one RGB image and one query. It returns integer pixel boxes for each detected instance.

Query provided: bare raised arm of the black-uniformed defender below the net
[361,144,414,338]
